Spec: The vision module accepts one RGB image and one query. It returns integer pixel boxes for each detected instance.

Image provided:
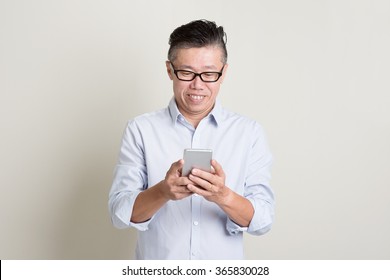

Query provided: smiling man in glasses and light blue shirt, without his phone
[109,20,274,259]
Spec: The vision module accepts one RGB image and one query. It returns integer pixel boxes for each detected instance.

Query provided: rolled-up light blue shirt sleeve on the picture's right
[226,124,275,235]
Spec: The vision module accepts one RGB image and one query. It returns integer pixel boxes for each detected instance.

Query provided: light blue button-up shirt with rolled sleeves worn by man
[109,99,274,259]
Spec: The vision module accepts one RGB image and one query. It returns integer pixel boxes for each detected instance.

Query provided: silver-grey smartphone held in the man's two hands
[181,149,213,176]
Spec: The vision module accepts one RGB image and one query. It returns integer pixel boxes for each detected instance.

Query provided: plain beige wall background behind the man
[0,0,390,259]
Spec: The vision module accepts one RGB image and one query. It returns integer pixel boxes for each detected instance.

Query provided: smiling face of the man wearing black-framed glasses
[166,46,227,122]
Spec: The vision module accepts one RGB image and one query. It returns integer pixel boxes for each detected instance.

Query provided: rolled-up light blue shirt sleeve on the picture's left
[108,121,152,231]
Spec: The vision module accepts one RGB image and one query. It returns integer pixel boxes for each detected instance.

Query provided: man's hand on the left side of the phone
[161,159,193,200]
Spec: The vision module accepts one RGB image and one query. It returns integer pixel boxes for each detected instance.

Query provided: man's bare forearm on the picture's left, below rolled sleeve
[130,181,168,223]
